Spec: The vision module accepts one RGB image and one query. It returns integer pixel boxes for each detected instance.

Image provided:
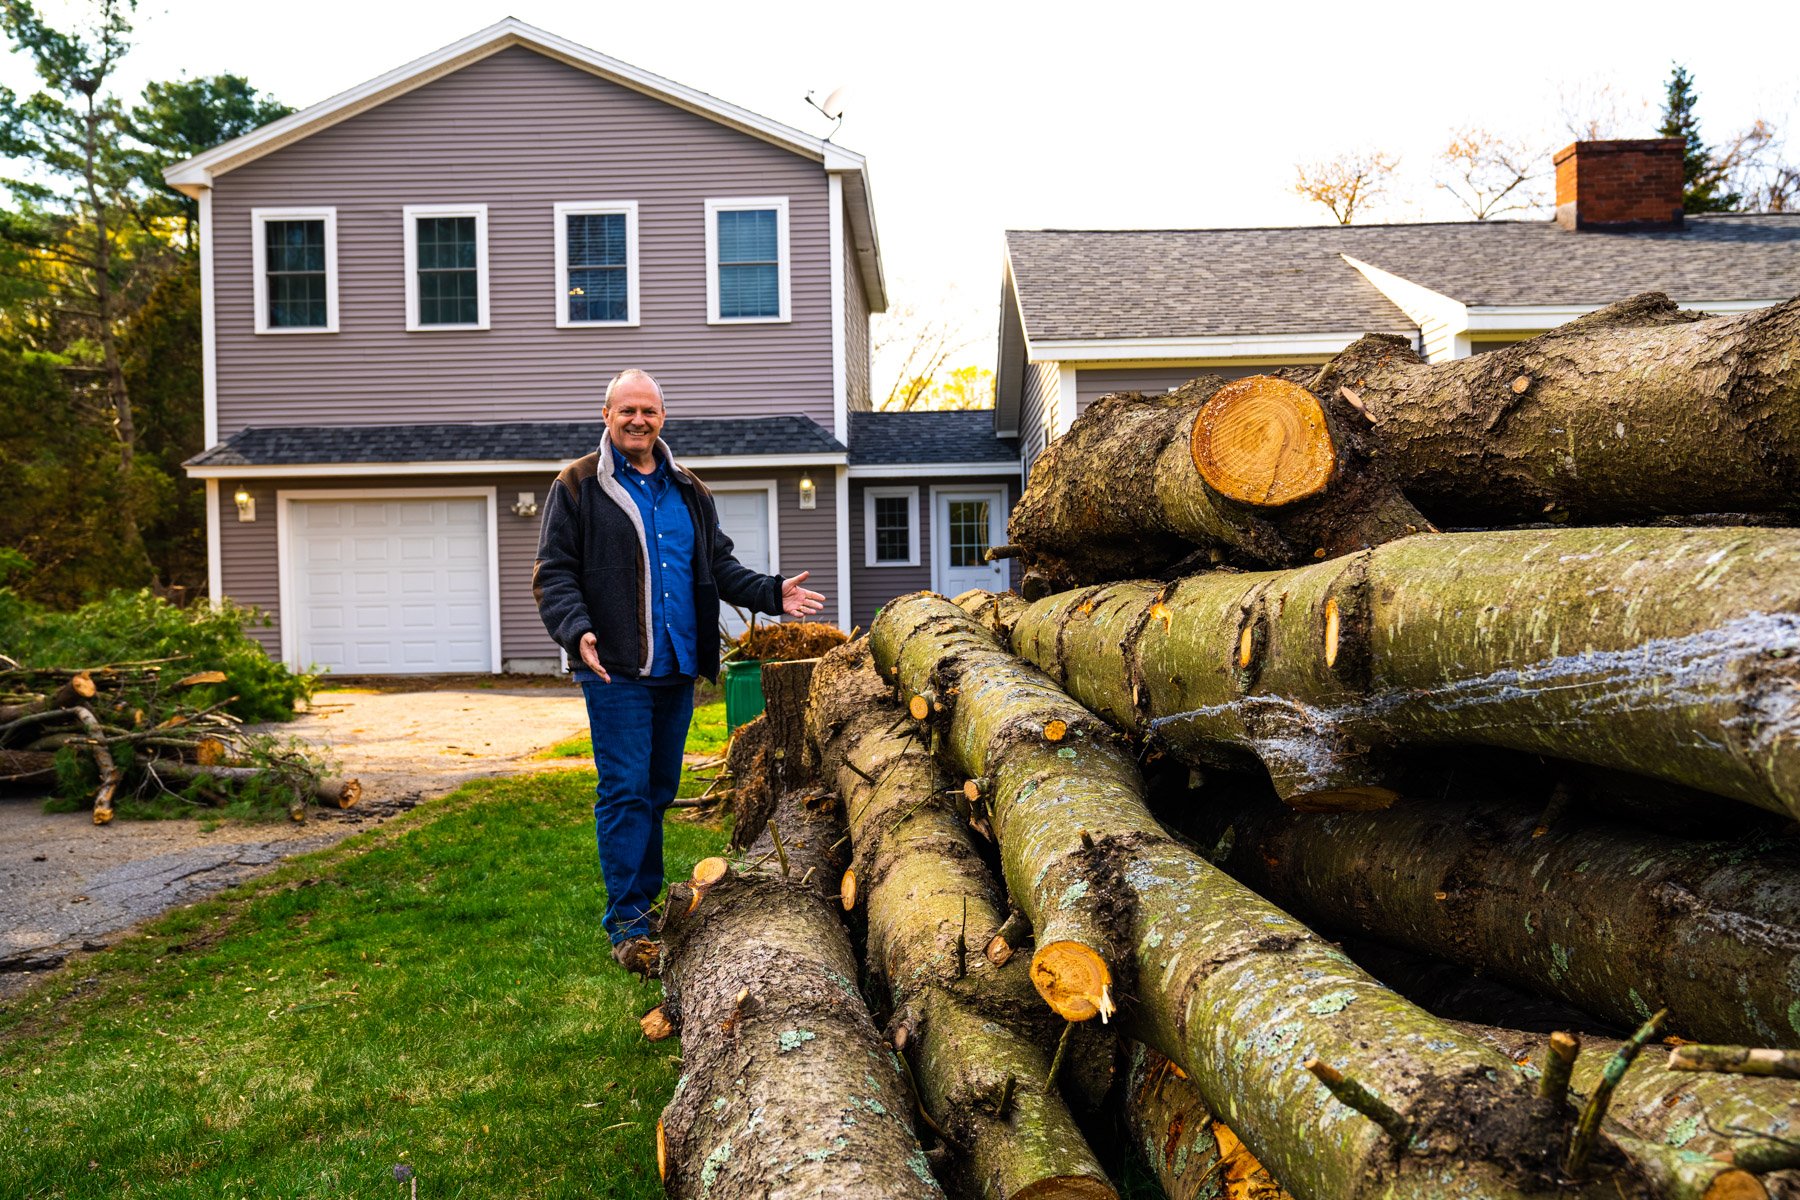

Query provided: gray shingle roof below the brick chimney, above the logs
[1006,214,1800,342]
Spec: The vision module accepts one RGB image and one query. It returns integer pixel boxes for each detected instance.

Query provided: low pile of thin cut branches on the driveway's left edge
[0,657,362,826]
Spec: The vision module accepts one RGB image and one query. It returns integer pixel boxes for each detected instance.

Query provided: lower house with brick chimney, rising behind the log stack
[994,139,1800,464]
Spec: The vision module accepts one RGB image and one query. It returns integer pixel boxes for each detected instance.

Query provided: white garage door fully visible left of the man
[286,497,495,675]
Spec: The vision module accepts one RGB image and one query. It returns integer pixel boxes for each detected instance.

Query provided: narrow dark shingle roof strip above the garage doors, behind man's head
[189,416,844,466]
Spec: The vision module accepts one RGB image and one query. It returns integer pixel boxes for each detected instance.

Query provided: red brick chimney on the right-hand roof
[1555,137,1685,230]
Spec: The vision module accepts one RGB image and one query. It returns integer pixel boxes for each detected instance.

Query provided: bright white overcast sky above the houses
[0,0,1800,394]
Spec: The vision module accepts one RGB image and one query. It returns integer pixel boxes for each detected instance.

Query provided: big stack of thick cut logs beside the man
[646,297,1800,1200]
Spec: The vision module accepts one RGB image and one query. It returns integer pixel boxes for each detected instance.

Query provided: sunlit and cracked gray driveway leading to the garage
[0,684,592,997]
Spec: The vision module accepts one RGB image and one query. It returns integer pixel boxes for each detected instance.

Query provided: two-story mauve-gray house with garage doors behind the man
[166,20,1019,673]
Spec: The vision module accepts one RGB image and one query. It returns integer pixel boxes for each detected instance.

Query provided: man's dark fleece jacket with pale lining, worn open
[531,434,781,678]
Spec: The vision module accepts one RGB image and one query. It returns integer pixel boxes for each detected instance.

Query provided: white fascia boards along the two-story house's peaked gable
[162,16,842,194]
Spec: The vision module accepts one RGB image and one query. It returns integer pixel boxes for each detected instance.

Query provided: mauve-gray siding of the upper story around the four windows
[212,47,832,437]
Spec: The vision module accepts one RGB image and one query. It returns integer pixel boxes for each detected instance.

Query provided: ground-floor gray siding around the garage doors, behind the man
[220,470,837,672]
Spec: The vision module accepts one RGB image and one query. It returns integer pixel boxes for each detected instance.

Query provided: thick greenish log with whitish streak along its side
[1013,529,1800,815]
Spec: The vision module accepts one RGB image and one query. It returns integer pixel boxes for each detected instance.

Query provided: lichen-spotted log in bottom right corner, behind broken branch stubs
[1458,1024,1800,1175]
